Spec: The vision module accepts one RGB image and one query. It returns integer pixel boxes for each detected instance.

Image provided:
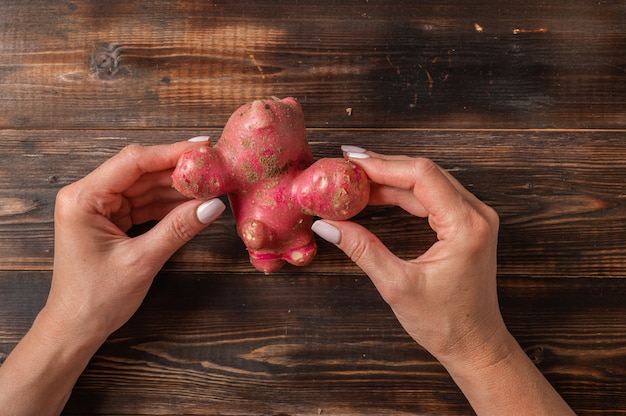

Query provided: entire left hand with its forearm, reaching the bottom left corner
[0,142,224,416]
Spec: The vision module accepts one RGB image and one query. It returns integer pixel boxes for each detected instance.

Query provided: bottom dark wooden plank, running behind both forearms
[0,272,626,415]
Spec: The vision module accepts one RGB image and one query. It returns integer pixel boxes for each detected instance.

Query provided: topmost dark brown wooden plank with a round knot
[0,0,626,129]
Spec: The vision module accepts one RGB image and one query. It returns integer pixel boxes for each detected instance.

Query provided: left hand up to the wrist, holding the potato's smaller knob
[45,142,224,338]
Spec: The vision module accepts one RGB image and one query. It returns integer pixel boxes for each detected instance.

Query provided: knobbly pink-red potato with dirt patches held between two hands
[172,98,369,274]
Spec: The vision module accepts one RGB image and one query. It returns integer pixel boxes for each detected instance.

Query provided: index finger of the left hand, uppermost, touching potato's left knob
[83,141,204,193]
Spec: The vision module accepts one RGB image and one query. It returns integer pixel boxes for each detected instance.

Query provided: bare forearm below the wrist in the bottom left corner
[0,309,104,416]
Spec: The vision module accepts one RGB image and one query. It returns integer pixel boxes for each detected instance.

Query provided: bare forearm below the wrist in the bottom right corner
[436,330,574,416]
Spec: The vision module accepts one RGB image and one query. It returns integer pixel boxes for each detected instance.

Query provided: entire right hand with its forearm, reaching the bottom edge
[313,147,574,416]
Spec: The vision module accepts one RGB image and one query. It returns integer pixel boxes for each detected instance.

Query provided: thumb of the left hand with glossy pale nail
[140,198,226,263]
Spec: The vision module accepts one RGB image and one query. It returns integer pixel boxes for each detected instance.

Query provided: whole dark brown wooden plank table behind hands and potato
[0,0,626,415]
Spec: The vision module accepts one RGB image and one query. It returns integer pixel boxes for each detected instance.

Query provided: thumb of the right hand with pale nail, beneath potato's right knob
[311,220,405,290]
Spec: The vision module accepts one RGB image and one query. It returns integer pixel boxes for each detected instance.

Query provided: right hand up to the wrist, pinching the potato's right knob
[315,152,504,360]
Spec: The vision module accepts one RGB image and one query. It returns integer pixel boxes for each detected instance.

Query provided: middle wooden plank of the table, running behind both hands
[0,129,626,277]
